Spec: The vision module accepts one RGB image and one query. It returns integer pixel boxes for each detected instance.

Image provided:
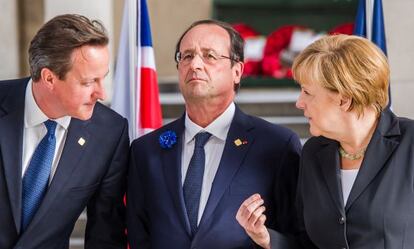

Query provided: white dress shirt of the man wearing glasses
[181,103,236,224]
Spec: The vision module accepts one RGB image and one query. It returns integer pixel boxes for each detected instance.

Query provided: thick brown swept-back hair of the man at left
[29,14,109,81]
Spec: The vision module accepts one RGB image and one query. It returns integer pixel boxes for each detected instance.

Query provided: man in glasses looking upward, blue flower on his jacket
[127,20,301,249]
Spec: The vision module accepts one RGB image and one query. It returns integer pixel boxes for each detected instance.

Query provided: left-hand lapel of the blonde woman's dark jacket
[317,141,344,214]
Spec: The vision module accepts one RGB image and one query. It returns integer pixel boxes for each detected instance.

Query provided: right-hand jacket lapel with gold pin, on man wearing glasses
[197,107,254,234]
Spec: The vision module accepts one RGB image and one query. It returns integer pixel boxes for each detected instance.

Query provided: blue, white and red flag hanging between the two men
[111,0,162,140]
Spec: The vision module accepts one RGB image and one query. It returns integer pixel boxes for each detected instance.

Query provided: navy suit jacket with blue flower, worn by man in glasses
[127,108,301,249]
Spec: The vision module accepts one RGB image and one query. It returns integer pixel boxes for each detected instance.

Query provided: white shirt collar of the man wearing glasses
[185,102,236,143]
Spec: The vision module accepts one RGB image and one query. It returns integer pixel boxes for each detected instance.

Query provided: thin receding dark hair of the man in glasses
[174,19,244,66]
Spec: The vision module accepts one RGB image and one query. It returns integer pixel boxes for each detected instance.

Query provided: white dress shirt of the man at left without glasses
[22,80,71,184]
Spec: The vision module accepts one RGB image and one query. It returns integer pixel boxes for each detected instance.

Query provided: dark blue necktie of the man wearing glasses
[183,132,211,235]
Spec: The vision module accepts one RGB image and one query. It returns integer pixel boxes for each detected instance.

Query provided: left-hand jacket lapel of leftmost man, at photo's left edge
[0,79,29,232]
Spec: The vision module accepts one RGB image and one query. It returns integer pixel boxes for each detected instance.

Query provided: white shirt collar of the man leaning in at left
[24,79,71,130]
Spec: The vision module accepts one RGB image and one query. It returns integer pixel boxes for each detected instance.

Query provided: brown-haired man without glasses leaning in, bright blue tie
[0,15,129,249]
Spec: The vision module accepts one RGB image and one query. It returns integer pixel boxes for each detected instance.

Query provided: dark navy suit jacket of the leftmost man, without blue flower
[0,79,129,249]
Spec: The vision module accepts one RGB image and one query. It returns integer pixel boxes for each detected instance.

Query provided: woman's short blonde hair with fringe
[292,35,390,115]
